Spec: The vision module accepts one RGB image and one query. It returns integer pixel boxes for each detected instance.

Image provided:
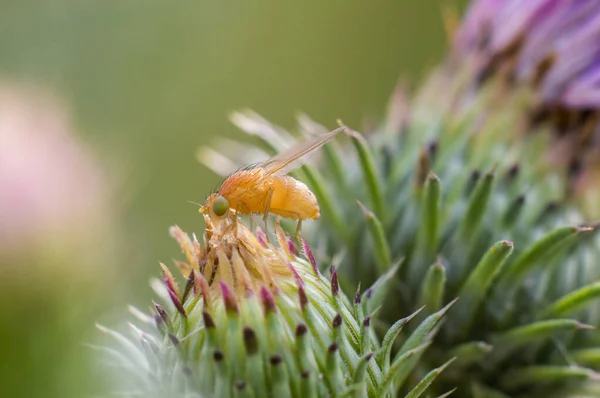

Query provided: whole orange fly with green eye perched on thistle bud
[200,126,347,233]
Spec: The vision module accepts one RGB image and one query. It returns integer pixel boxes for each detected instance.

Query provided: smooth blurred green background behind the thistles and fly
[0,0,463,397]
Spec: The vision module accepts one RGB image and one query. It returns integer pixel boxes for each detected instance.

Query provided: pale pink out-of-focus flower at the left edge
[0,83,107,252]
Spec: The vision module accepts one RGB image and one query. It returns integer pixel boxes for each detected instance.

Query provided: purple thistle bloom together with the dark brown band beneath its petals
[447,0,600,201]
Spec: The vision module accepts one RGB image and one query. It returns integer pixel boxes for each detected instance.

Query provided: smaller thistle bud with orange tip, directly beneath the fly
[101,202,453,398]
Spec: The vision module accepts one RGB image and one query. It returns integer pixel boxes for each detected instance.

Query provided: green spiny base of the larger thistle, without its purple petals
[219,75,600,397]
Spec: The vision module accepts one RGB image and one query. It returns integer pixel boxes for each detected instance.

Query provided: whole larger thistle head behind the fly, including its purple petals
[201,0,600,397]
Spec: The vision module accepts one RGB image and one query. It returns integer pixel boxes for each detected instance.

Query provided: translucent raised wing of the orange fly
[257,126,347,177]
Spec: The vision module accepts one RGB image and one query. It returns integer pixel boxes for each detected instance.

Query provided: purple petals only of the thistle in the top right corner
[455,0,600,109]
